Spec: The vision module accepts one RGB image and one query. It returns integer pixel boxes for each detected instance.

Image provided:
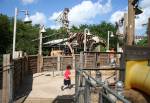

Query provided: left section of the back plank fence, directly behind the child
[41,54,80,74]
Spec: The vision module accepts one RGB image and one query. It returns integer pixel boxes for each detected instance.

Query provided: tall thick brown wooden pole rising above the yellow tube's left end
[127,0,135,45]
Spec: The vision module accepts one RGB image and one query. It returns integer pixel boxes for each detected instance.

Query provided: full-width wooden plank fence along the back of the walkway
[40,52,121,77]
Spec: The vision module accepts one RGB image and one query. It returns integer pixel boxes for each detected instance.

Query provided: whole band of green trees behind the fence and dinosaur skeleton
[0,14,117,55]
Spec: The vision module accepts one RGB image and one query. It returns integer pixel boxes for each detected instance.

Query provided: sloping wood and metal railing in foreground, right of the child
[75,68,130,103]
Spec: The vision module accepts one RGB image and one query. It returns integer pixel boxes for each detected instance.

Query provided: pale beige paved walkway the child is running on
[16,71,75,103]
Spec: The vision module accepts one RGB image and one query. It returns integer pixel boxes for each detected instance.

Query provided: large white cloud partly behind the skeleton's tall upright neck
[49,0,112,26]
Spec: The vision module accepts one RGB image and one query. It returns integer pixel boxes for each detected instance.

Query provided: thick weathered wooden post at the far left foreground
[2,54,12,103]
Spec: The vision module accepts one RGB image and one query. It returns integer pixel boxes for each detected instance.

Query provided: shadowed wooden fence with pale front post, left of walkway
[1,54,28,103]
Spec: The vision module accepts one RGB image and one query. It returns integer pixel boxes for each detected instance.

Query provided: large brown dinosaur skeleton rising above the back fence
[56,8,106,54]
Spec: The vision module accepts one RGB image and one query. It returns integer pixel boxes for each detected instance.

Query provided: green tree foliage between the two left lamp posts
[16,20,39,54]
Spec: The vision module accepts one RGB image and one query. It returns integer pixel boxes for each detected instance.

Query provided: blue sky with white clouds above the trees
[0,0,150,35]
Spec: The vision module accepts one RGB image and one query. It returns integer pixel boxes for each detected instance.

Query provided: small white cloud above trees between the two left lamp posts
[30,12,46,24]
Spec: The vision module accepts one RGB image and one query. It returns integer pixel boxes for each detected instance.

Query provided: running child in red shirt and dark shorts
[61,65,71,90]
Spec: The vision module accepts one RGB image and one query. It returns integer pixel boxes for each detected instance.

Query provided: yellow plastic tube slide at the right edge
[125,60,150,95]
